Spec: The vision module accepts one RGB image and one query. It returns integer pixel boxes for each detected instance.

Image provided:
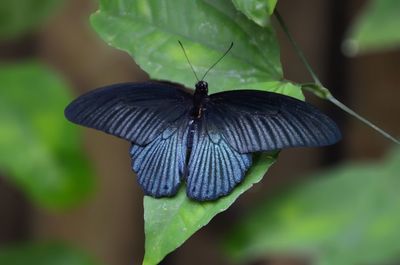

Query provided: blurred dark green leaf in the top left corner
[0,0,64,39]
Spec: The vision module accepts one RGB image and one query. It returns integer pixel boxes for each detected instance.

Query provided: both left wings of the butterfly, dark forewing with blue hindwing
[65,83,192,197]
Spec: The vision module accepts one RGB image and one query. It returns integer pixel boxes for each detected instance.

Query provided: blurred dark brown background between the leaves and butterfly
[0,0,400,265]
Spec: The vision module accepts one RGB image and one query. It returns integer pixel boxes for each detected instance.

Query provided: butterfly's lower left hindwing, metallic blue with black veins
[130,119,187,197]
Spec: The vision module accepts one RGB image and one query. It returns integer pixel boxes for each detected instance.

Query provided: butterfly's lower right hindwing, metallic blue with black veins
[186,116,252,201]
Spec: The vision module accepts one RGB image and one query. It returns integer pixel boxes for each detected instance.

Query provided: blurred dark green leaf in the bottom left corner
[0,243,99,265]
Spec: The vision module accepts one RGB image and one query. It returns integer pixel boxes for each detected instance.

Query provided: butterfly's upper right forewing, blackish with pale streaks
[207,90,341,153]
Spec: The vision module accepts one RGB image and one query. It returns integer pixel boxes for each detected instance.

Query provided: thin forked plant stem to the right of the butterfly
[275,10,400,145]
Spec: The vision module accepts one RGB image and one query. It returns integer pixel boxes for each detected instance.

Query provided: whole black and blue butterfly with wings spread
[65,42,341,201]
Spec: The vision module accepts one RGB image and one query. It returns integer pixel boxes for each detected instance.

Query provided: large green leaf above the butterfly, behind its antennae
[91,0,282,93]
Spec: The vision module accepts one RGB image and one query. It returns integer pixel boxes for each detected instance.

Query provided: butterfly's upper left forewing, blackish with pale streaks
[65,83,192,145]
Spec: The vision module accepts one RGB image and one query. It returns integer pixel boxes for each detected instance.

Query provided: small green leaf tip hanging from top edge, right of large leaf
[232,0,278,27]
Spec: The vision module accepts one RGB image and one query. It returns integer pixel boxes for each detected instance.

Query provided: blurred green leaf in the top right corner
[344,0,400,55]
